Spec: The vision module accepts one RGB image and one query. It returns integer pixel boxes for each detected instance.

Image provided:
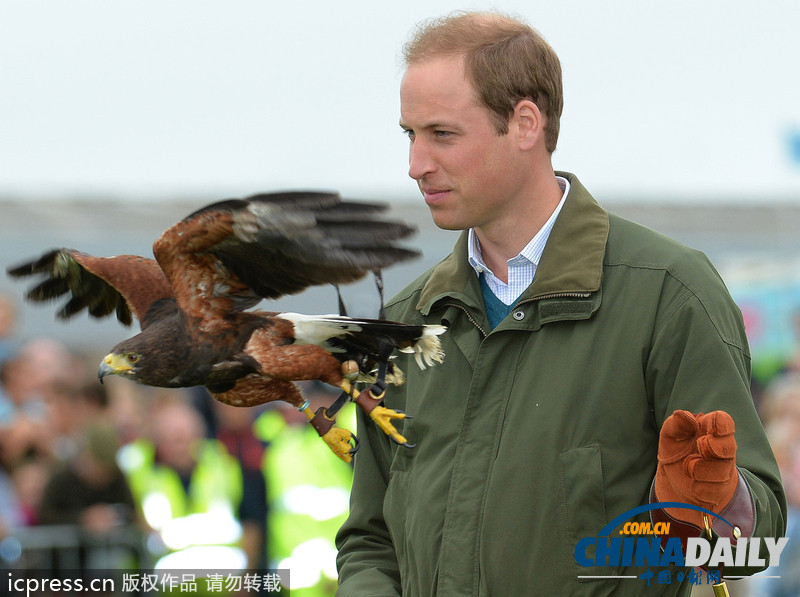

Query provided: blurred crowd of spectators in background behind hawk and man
[0,286,800,597]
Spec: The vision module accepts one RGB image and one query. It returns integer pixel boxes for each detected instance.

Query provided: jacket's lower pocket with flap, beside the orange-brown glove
[560,444,619,583]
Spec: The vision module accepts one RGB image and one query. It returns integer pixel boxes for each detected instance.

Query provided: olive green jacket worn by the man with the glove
[337,174,786,597]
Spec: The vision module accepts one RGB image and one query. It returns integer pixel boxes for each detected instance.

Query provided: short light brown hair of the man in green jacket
[403,12,564,153]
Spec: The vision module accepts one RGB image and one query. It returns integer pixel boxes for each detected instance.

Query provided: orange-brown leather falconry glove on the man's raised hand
[655,410,739,529]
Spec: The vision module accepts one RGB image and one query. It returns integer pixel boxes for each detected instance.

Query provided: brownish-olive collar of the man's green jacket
[417,172,608,315]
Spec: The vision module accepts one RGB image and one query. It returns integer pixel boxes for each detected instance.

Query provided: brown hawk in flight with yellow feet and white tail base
[8,191,445,462]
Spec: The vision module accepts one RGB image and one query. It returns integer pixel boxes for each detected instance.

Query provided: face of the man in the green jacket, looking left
[400,56,524,230]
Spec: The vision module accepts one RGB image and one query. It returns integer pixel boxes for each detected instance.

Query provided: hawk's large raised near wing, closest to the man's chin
[153,191,419,320]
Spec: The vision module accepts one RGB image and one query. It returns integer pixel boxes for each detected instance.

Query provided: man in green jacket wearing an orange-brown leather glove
[338,13,785,597]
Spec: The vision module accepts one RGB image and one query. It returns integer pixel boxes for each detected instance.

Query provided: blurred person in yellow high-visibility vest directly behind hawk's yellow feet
[255,383,355,597]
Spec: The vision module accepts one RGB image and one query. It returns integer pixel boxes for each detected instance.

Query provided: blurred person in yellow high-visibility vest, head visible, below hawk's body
[119,400,263,570]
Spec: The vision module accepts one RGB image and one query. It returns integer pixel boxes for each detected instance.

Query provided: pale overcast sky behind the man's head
[0,0,800,200]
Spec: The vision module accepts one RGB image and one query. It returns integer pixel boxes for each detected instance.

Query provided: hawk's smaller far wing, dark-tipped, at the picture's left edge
[8,248,173,328]
